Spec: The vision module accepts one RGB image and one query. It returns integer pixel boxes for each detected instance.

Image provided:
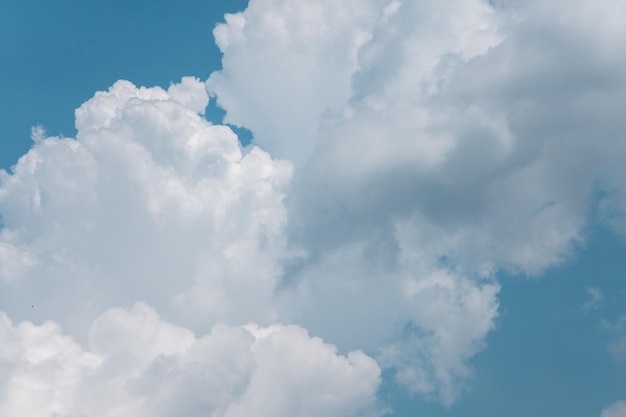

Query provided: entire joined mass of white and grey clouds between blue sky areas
[0,0,626,417]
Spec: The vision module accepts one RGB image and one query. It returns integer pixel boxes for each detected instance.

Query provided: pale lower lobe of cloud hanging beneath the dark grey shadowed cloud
[270,216,499,405]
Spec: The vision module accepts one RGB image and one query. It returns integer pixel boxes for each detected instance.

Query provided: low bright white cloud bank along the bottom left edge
[0,303,381,417]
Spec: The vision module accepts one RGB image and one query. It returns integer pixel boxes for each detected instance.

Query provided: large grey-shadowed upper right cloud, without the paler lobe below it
[208,0,624,275]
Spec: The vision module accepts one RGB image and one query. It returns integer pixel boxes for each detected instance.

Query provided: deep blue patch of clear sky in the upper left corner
[0,0,246,167]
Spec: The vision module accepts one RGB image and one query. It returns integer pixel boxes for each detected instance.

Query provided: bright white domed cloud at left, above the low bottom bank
[0,78,291,330]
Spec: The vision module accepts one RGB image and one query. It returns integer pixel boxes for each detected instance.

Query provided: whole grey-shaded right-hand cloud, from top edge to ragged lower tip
[207,0,626,403]
